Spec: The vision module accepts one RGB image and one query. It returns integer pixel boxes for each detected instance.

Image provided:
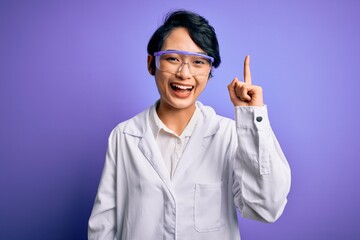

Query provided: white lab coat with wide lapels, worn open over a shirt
[88,102,290,240]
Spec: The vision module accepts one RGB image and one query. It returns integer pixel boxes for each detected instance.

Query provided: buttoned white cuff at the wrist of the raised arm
[235,105,270,131]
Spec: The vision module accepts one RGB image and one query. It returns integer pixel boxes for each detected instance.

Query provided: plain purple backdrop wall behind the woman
[0,0,360,240]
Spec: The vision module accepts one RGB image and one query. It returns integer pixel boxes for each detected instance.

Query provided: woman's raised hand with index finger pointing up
[228,56,264,106]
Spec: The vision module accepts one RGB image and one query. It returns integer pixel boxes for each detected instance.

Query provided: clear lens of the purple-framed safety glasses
[155,51,211,77]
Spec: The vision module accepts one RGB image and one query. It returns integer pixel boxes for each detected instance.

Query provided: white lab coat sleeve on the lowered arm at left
[88,131,120,240]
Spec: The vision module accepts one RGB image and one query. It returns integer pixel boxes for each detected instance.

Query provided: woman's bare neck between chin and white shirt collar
[157,102,196,135]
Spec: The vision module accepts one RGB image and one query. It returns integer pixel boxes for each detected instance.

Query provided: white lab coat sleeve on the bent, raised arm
[233,106,291,222]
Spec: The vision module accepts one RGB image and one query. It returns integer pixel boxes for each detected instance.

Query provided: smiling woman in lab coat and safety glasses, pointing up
[89,11,290,240]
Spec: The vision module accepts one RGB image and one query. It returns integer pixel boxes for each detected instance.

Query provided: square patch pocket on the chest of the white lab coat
[194,182,225,232]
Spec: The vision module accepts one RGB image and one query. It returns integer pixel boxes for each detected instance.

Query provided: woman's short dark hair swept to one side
[147,10,221,76]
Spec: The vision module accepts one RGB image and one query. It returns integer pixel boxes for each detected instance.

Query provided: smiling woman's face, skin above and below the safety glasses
[150,28,209,113]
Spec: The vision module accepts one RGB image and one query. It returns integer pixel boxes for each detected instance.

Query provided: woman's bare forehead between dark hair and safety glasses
[161,27,204,52]
